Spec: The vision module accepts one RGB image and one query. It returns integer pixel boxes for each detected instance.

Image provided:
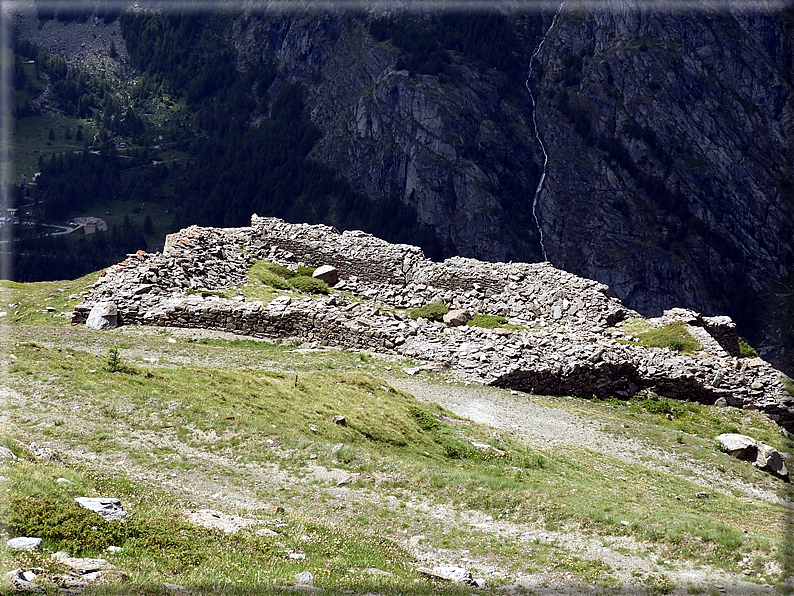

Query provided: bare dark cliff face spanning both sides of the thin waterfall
[229,1,794,367]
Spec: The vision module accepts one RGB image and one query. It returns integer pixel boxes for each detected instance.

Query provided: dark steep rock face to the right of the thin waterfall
[537,2,794,363]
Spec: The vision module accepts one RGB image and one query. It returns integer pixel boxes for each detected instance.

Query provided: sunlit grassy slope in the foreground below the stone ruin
[0,274,790,594]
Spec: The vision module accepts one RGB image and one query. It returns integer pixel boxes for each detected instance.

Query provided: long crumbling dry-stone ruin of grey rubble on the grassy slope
[72,215,794,429]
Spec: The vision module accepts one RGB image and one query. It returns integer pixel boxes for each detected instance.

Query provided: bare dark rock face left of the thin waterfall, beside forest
[230,15,540,260]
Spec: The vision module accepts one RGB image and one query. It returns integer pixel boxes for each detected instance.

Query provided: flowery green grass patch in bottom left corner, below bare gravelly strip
[0,462,446,595]
